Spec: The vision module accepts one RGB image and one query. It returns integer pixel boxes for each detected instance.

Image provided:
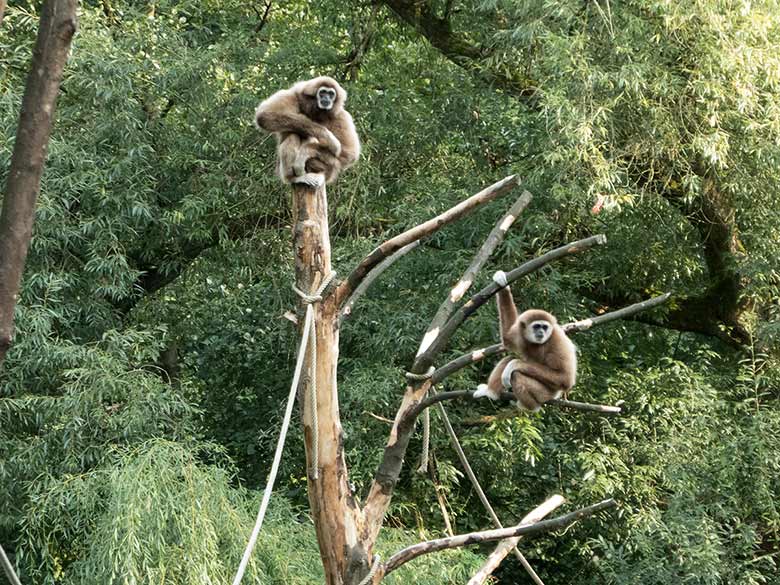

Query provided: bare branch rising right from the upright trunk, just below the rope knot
[336,175,519,306]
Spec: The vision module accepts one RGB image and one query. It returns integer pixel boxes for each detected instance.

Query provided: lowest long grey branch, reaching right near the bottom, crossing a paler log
[385,498,617,575]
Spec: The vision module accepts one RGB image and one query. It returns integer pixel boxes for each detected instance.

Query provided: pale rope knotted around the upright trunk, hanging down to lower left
[233,272,336,585]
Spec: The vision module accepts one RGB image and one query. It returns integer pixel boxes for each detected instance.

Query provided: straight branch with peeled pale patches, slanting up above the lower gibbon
[420,191,531,348]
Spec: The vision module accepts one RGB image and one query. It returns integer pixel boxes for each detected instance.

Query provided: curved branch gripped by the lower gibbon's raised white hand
[411,234,607,374]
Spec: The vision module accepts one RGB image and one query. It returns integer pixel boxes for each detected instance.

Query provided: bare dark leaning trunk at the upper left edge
[0,0,77,364]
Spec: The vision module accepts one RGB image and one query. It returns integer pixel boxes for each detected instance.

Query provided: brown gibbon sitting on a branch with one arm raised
[474,271,577,411]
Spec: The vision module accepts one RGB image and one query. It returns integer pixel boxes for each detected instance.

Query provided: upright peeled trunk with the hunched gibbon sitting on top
[293,185,371,585]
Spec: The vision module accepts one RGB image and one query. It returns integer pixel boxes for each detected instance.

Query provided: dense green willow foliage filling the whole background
[0,0,780,584]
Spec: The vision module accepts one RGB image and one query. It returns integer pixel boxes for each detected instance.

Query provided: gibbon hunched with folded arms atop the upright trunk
[255,76,360,187]
